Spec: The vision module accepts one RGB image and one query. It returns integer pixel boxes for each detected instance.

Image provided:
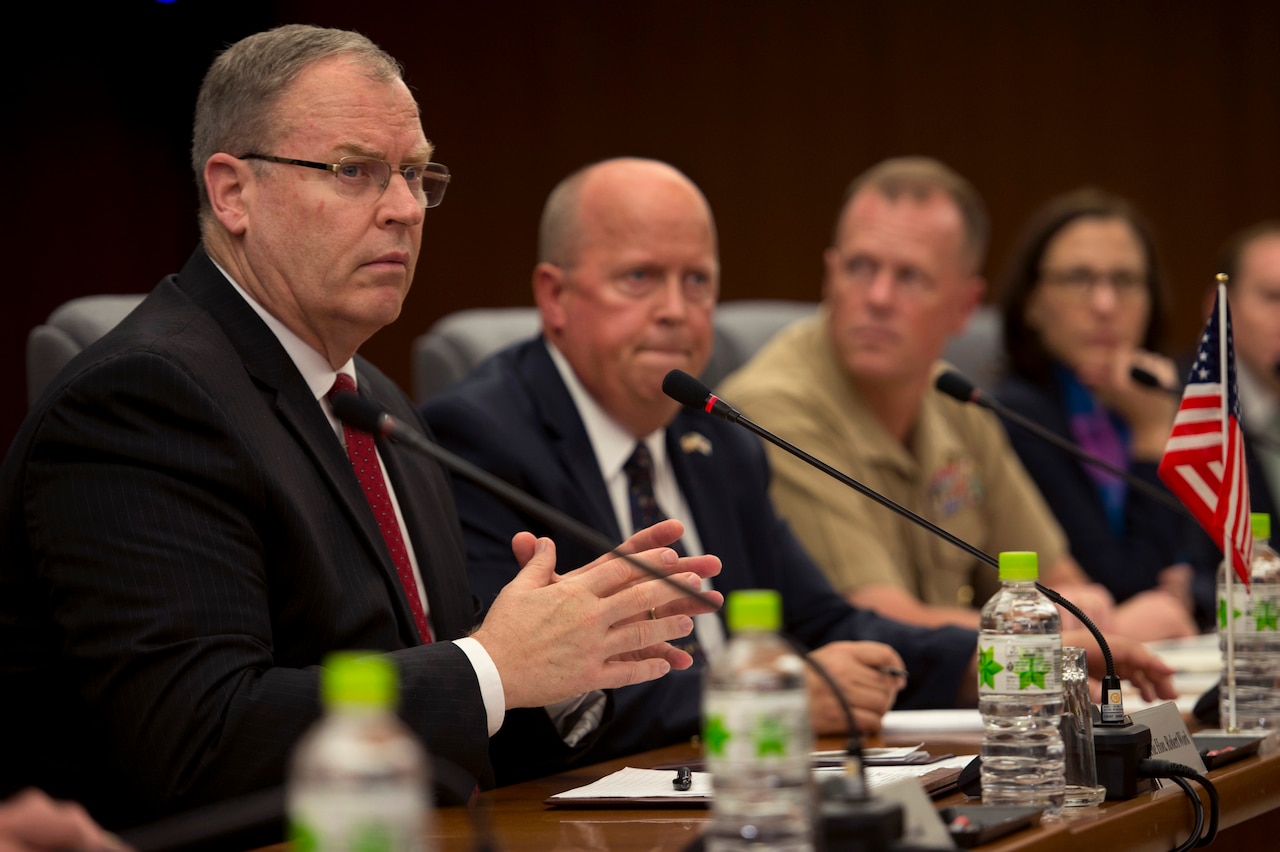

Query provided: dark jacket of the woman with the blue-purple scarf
[996,377,1213,618]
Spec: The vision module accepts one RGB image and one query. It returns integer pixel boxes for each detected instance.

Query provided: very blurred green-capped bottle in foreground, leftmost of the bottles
[285,652,433,852]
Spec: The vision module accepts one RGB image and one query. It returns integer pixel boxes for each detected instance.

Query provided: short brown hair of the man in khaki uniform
[835,157,991,272]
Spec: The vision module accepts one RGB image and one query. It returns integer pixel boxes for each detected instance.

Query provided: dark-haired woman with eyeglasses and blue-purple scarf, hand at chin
[996,189,1212,640]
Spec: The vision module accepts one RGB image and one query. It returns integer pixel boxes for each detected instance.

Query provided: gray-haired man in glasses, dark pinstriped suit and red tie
[0,26,718,826]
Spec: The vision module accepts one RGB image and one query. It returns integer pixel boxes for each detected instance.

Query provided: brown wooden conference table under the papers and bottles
[433,739,1280,852]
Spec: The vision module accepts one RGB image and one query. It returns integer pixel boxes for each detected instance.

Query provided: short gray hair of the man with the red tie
[191,24,403,220]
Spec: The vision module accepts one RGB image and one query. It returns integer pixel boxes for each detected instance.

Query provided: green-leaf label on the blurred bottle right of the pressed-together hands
[703,690,813,768]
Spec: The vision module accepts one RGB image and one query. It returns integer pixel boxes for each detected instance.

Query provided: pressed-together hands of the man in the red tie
[472,521,723,709]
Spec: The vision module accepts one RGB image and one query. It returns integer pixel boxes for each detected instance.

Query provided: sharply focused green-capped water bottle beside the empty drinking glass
[978,553,1066,816]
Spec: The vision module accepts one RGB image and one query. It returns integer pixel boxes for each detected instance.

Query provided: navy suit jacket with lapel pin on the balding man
[422,339,975,783]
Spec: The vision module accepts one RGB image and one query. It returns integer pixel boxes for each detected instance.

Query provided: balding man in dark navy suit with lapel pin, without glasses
[422,159,974,783]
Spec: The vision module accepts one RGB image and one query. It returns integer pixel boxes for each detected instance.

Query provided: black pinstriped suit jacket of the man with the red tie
[0,249,488,826]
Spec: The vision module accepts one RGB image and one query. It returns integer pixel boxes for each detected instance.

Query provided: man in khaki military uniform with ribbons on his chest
[721,157,1111,628]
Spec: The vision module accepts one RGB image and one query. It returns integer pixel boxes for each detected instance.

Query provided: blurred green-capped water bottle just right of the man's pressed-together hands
[703,590,815,852]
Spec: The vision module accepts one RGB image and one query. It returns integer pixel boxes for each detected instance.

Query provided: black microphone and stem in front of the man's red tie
[329,391,719,610]
